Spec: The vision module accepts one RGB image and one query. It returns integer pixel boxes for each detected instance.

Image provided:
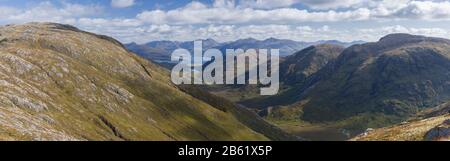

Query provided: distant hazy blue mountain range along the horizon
[125,38,364,67]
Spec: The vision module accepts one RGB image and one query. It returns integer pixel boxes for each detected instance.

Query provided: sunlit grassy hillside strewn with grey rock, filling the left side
[0,23,267,140]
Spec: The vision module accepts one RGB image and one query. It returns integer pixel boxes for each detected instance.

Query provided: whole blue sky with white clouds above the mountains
[0,0,450,43]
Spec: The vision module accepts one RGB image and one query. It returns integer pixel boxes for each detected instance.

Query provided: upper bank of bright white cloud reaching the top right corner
[137,0,450,24]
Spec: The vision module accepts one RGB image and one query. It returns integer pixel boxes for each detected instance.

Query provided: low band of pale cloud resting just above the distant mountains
[72,19,450,43]
